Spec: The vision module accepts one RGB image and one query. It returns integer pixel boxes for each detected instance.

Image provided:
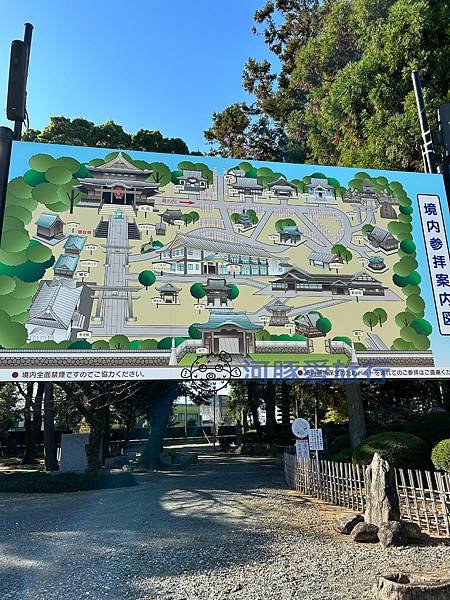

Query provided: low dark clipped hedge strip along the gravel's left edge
[0,473,137,494]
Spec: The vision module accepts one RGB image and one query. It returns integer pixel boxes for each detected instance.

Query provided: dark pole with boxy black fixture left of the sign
[0,23,33,242]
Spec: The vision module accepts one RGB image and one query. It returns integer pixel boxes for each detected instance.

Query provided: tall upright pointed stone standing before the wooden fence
[364,453,400,527]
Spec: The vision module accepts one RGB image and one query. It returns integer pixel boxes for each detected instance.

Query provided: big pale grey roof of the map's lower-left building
[27,280,82,329]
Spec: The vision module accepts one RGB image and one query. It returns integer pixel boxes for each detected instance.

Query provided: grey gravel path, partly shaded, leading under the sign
[0,455,450,600]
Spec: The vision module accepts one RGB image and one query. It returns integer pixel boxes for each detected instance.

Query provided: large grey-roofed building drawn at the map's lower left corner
[25,280,85,342]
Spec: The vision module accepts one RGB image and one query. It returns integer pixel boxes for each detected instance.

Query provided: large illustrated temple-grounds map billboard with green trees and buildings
[0,142,450,381]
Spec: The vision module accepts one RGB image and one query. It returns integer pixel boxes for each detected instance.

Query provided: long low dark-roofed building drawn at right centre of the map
[272,267,386,296]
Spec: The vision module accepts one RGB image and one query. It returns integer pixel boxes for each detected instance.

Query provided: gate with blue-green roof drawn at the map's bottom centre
[196,310,262,355]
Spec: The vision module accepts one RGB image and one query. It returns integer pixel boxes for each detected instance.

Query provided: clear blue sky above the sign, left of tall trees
[0,0,267,151]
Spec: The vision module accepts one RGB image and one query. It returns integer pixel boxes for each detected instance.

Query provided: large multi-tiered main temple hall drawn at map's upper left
[77,152,159,210]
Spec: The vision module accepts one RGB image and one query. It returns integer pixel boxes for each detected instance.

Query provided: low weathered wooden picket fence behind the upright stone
[284,452,450,537]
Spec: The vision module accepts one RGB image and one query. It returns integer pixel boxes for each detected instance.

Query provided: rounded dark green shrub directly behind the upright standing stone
[352,431,429,469]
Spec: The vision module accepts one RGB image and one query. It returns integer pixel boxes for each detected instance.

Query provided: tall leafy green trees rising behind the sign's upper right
[206,0,450,171]
